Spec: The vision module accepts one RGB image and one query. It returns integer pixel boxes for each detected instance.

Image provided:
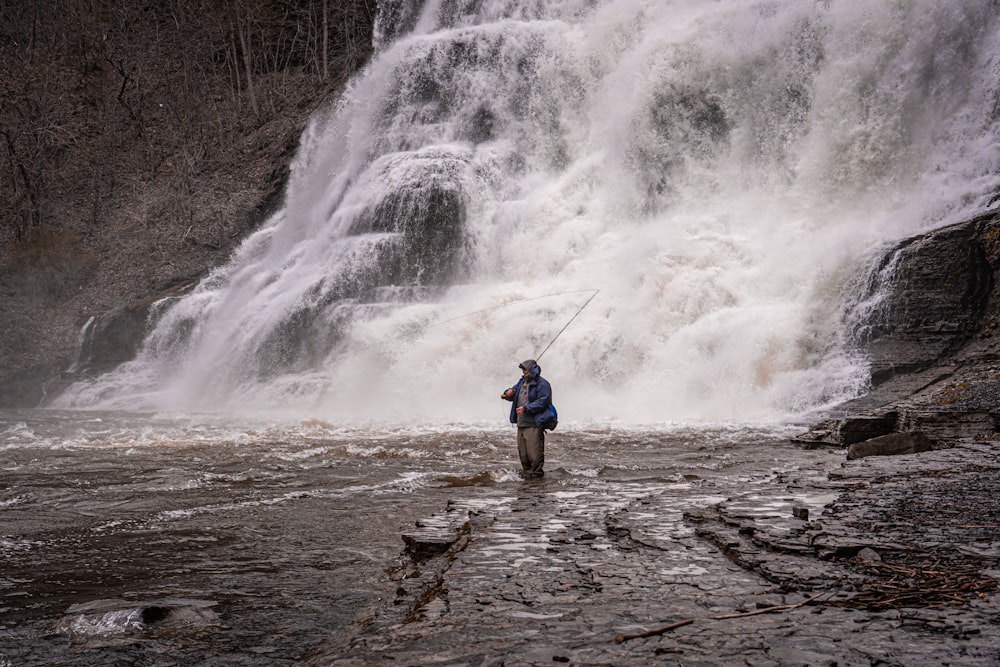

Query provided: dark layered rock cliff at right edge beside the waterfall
[801,211,1000,445]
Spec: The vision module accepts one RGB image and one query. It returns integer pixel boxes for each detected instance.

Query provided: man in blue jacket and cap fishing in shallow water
[501,359,552,477]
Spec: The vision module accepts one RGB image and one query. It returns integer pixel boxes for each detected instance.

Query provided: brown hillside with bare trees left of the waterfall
[0,0,376,405]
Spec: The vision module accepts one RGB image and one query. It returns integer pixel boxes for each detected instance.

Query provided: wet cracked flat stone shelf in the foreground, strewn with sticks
[309,441,1000,666]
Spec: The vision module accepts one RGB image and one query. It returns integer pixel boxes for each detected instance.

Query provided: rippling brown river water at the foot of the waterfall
[0,411,832,667]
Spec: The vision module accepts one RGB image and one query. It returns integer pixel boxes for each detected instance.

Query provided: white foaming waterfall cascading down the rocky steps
[57,0,1000,422]
